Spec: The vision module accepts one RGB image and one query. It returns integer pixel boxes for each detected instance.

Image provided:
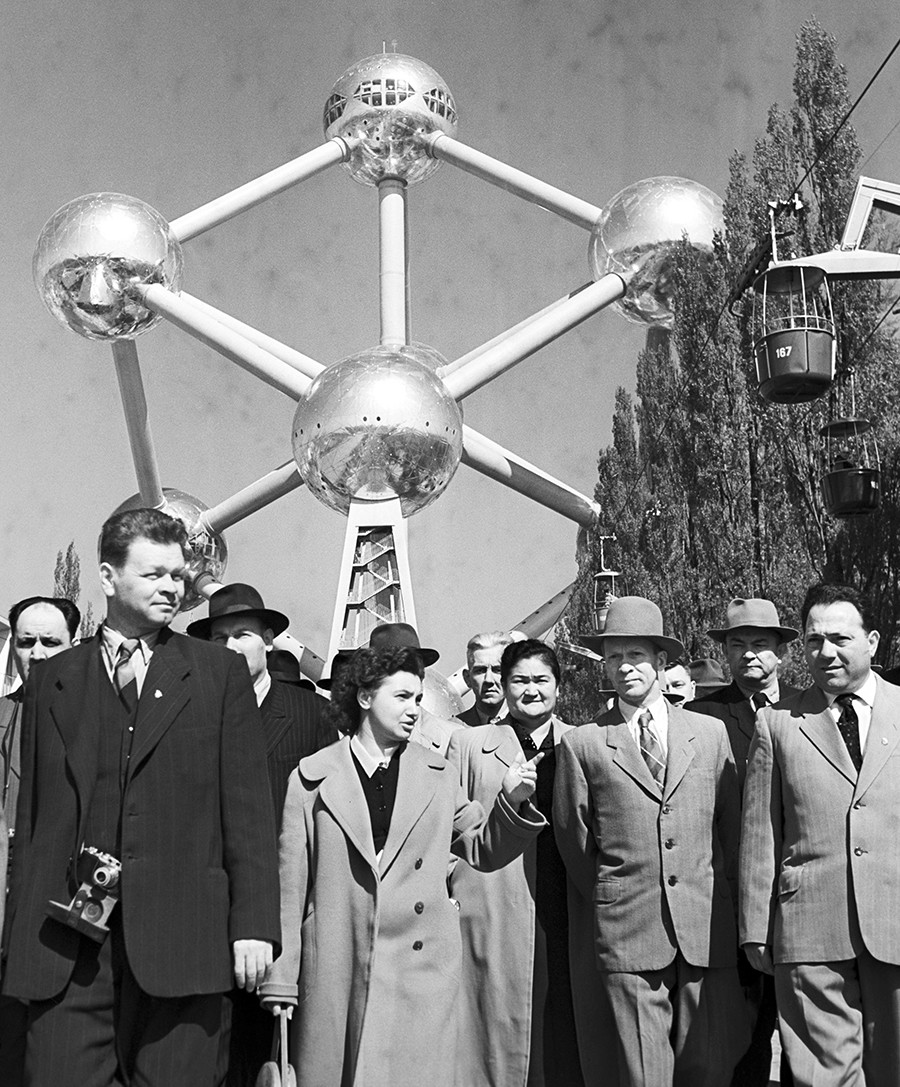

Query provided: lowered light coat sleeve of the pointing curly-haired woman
[260,770,310,1004]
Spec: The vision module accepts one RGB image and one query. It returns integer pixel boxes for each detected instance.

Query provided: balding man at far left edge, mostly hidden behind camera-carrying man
[0,597,82,1087]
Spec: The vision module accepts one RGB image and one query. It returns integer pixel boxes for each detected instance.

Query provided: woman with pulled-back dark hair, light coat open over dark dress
[447,639,615,1087]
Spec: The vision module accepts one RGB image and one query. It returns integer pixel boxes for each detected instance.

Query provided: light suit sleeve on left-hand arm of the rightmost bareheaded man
[740,711,783,945]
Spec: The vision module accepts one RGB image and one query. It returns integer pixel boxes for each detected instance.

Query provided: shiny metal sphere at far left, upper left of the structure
[33,192,183,340]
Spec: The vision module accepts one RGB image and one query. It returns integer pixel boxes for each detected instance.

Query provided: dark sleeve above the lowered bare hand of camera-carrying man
[221,654,282,953]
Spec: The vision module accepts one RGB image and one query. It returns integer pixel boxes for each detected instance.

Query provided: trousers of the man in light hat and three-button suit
[601,953,750,1087]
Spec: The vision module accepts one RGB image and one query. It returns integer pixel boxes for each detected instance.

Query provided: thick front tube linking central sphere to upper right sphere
[443,273,625,400]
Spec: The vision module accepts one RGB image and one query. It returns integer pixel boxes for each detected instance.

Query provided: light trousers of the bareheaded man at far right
[775,951,900,1087]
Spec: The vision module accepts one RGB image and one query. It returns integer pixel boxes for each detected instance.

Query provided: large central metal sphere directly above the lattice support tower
[292,343,462,517]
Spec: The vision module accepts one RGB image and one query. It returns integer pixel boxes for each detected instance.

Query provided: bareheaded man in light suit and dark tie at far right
[740,585,900,1087]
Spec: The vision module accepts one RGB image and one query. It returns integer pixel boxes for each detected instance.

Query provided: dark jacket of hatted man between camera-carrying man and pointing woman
[260,679,338,826]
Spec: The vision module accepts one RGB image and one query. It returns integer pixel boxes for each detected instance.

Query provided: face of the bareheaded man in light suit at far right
[803,600,878,695]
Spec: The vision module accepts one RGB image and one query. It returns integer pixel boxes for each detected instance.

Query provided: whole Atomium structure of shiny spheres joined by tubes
[34,52,723,689]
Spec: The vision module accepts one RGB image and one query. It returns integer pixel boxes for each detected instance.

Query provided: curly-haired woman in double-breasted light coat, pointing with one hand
[260,648,547,1087]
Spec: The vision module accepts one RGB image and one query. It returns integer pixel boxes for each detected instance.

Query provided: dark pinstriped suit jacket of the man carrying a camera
[3,630,280,1000]
